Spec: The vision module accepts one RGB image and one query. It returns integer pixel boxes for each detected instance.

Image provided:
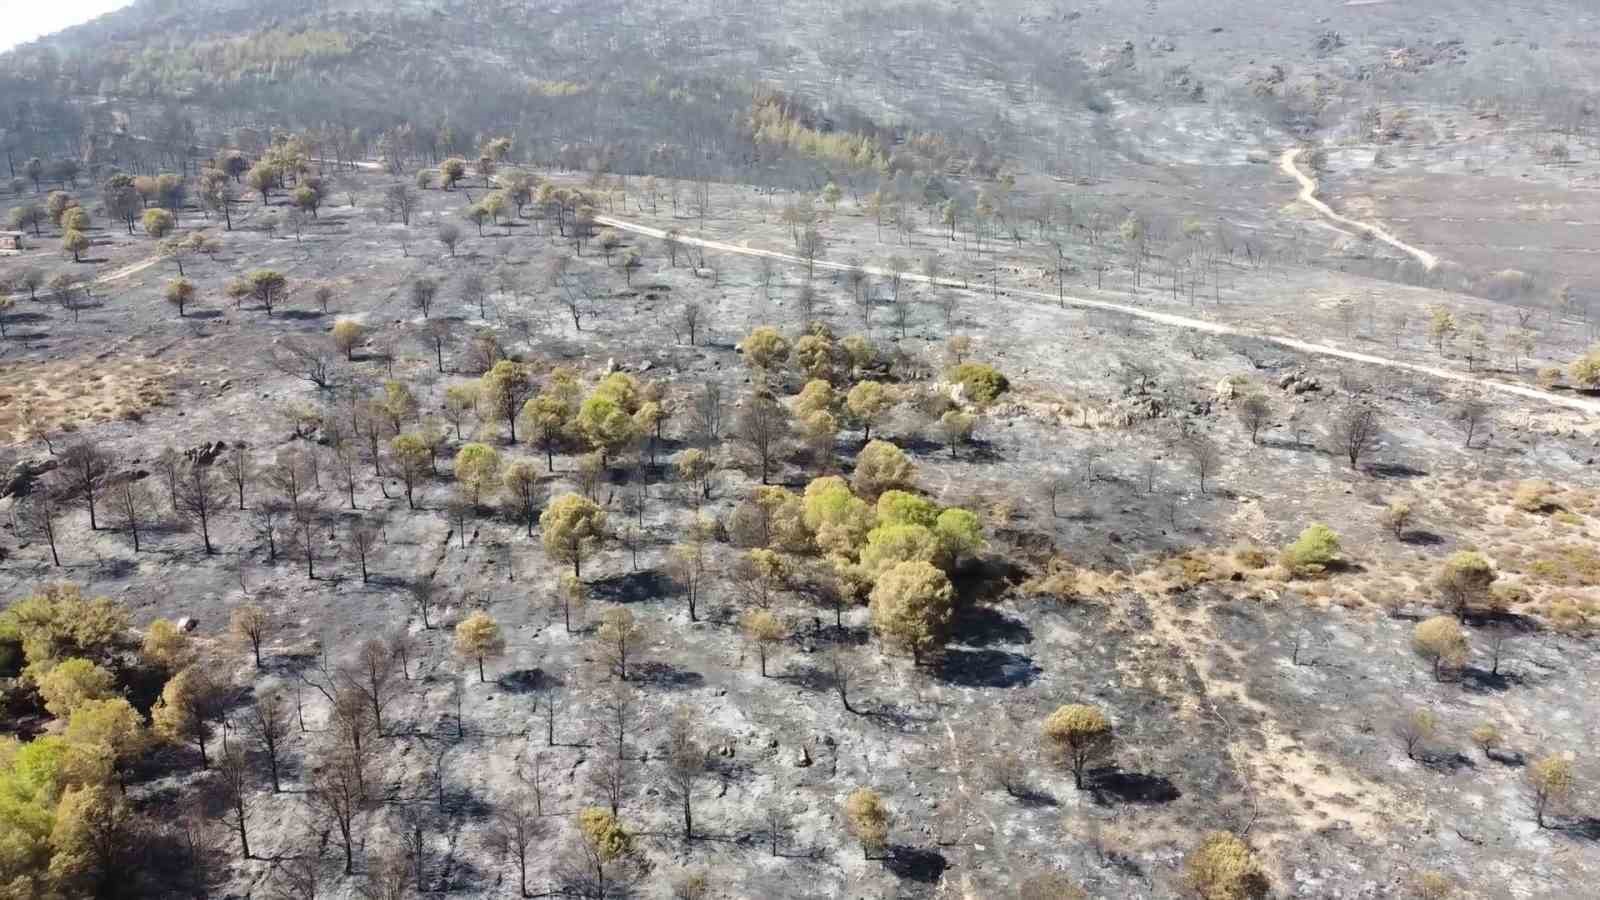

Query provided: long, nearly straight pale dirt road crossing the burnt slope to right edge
[595,212,1600,413]
